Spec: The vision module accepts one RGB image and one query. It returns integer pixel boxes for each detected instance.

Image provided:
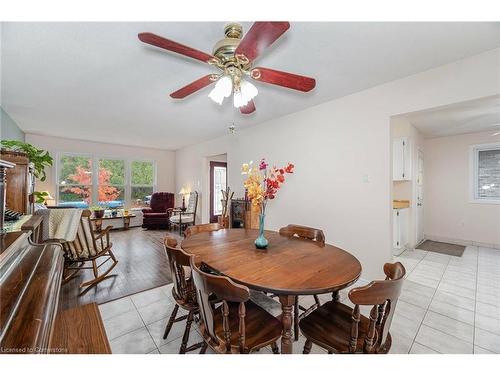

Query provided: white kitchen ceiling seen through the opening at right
[404,95,500,138]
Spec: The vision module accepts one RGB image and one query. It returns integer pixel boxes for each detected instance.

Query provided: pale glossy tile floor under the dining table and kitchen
[99,246,500,354]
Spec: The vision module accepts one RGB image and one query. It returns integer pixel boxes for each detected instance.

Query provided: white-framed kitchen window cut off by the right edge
[471,143,500,204]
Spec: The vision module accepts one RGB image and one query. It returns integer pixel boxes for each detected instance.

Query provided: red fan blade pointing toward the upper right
[234,22,290,61]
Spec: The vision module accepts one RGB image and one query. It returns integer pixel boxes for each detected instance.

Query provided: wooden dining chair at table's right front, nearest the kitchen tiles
[300,262,406,354]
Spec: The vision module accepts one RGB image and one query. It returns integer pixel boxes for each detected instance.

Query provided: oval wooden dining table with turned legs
[181,229,361,354]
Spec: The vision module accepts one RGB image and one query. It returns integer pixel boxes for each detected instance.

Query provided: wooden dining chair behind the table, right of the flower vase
[279,224,325,341]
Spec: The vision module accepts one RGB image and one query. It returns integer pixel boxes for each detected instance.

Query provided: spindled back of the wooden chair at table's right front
[349,262,406,353]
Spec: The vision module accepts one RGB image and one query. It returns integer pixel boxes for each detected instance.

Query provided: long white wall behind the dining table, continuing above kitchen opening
[176,49,500,279]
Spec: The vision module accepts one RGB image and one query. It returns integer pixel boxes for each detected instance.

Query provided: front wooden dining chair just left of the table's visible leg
[191,256,282,354]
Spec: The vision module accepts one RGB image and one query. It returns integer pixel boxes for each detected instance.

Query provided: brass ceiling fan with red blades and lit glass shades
[138,22,316,114]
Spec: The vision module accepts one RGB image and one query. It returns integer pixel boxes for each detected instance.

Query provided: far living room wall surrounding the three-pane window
[26,134,176,197]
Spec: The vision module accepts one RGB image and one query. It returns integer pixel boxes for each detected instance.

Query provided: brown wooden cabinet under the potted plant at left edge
[1,150,35,214]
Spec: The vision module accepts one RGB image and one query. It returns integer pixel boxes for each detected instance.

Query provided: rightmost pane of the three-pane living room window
[131,161,154,207]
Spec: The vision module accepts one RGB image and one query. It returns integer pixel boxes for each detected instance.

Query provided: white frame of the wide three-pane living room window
[54,152,158,207]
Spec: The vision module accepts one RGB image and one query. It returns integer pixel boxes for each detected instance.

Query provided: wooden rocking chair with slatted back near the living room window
[61,210,118,296]
